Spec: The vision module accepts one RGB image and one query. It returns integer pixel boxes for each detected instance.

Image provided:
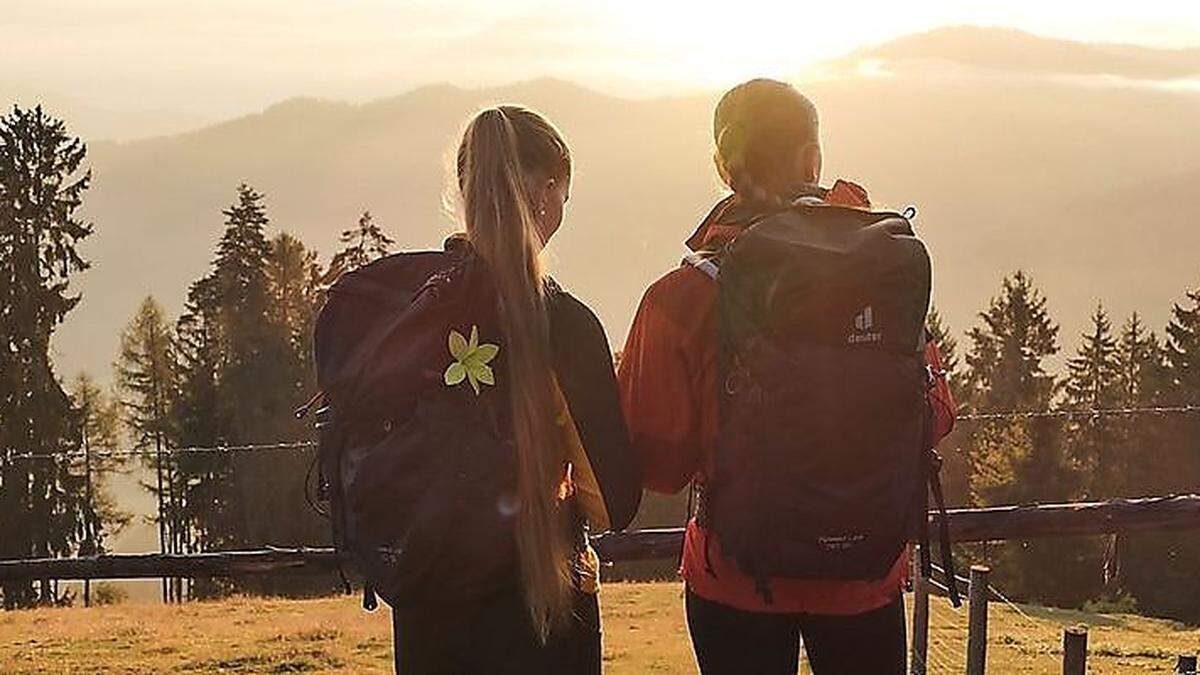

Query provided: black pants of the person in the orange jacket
[686,591,907,675]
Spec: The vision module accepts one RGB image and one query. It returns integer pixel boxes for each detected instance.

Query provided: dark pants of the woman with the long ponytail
[392,590,600,675]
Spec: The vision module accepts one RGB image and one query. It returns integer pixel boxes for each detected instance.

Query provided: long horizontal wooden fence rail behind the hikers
[0,495,1200,583]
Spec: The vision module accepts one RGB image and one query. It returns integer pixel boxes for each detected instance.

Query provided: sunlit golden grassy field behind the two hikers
[0,584,1200,675]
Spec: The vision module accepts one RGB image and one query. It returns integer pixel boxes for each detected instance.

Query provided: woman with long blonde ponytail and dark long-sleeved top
[394,106,641,674]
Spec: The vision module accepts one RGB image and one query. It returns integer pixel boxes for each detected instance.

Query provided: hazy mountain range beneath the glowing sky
[63,28,1200,389]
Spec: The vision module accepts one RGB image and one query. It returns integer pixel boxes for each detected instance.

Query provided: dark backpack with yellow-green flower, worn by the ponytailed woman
[314,243,517,609]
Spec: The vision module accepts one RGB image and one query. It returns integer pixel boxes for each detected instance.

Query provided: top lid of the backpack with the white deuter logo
[718,203,931,352]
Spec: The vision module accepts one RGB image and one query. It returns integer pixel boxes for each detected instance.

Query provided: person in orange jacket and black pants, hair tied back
[618,79,954,675]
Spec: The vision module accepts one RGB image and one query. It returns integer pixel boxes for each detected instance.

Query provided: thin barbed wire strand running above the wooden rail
[0,405,1200,460]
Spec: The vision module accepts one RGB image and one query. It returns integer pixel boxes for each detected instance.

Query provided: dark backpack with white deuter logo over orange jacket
[701,203,955,602]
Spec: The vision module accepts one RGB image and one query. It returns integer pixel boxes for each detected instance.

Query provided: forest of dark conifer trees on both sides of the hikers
[0,103,1200,621]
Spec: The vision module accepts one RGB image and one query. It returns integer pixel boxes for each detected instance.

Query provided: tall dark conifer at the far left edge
[0,107,97,608]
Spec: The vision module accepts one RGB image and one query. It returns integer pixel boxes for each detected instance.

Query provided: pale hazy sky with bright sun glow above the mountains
[7,0,1200,136]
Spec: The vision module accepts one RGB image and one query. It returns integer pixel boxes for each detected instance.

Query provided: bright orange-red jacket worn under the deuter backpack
[618,180,955,615]
